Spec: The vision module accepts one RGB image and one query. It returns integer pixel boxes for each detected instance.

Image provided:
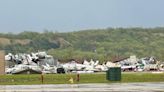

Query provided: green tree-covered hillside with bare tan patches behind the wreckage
[0,28,164,62]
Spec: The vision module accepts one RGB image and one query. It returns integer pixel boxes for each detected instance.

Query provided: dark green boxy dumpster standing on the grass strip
[106,67,121,81]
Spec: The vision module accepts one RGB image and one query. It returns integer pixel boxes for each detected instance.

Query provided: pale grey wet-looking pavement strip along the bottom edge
[0,82,164,92]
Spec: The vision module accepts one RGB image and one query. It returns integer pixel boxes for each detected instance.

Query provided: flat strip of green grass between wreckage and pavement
[0,73,164,85]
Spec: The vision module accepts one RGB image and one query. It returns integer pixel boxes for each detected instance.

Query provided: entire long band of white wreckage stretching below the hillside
[5,52,164,74]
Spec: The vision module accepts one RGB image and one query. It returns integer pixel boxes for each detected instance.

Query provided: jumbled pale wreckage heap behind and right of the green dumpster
[111,56,162,71]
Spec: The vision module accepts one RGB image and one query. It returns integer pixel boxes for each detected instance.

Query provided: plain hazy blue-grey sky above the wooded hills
[0,0,164,33]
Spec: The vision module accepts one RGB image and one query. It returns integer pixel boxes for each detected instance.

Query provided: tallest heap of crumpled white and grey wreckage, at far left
[5,52,58,74]
